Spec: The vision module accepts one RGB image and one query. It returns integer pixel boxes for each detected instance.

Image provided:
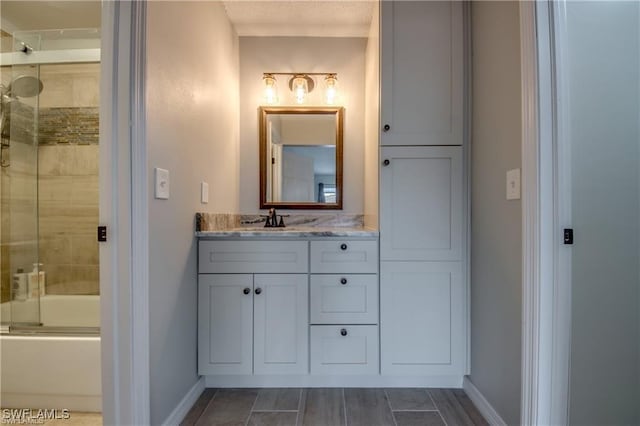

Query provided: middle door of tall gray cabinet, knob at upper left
[380,146,463,261]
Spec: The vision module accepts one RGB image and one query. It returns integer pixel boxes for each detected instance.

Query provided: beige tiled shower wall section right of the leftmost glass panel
[38,64,100,294]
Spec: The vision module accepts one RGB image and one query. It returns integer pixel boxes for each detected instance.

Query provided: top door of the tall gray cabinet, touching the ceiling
[380,1,464,145]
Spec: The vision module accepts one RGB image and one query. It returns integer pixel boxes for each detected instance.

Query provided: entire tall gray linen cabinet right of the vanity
[380,1,468,385]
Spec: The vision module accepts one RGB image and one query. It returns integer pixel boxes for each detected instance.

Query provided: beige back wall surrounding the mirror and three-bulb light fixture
[240,37,366,214]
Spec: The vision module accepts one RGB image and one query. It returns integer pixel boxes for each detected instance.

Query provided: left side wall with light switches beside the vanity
[147,2,239,424]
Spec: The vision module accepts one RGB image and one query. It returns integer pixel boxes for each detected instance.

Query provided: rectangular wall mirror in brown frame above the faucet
[259,107,344,210]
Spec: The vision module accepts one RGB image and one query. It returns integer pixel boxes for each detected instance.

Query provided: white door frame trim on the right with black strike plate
[520,0,571,425]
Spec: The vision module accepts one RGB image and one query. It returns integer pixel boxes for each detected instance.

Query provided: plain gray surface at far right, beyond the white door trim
[561,2,640,425]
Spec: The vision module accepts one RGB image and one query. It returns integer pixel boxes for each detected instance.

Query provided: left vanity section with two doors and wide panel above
[198,240,309,375]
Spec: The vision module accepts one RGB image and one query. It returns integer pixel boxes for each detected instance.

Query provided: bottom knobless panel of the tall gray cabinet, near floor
[380,262,466,375]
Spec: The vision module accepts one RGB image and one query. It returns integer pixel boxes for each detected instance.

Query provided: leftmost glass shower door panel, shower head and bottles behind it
[0,36,44,325]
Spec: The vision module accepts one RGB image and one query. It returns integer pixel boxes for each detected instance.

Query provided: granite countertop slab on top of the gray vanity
[196,226,379,238]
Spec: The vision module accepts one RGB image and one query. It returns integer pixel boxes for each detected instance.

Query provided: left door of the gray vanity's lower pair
[198,274,253,375]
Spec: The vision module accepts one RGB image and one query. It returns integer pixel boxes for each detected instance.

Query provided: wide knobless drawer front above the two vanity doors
[198,240,308,274]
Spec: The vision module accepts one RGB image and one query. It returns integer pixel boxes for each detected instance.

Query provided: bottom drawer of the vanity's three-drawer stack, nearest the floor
[311,325,379,374]
